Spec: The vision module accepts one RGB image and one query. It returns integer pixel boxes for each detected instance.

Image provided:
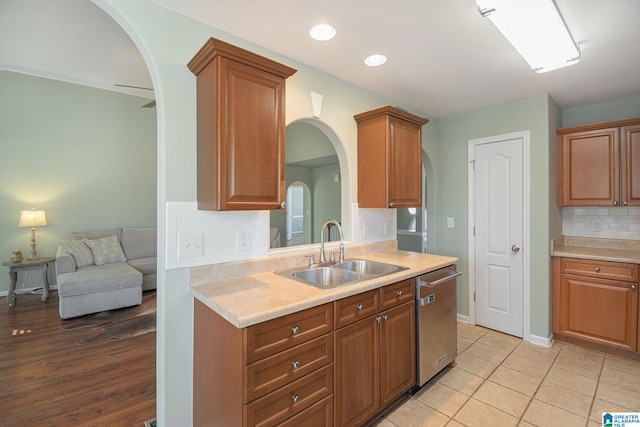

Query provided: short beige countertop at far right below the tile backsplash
[551,236,640,264]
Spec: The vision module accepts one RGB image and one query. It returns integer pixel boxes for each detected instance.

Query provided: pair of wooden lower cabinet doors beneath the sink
[334,301,416,426]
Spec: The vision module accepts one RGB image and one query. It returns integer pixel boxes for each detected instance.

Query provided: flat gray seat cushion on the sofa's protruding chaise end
[58,262,142,297]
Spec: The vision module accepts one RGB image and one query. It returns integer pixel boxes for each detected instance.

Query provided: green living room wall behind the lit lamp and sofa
[0,71,156,292]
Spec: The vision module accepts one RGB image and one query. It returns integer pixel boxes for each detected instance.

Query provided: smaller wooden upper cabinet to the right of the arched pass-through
[354,106,429,208]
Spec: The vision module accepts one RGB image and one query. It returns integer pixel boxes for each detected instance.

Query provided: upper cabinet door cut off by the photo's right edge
[620,125,640,206]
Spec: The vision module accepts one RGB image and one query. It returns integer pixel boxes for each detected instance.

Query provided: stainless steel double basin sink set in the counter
[275,259,408,289]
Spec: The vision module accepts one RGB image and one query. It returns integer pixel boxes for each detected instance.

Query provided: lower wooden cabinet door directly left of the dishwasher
[380,301,416,408]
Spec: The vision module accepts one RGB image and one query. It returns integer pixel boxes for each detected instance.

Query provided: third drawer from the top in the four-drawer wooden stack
[245,365,333,427]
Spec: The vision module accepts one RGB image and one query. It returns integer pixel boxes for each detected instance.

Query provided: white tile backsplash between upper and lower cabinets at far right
[562,207,640,240]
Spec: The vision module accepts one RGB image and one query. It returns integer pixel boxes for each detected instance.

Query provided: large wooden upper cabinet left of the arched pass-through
[188,38,296,210]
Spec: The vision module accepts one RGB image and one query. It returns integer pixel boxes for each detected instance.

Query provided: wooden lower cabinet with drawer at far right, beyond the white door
[552,258,638,352]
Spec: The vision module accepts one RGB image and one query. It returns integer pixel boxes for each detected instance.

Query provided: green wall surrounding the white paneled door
[436,95,555,337]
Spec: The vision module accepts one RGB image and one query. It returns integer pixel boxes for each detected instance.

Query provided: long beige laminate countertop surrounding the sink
[191,251,458,328]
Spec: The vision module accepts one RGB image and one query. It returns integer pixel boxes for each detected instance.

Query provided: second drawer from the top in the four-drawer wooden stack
[245,334,333,402]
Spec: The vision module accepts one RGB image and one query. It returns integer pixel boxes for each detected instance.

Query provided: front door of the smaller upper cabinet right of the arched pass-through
[387,117,422,208]
